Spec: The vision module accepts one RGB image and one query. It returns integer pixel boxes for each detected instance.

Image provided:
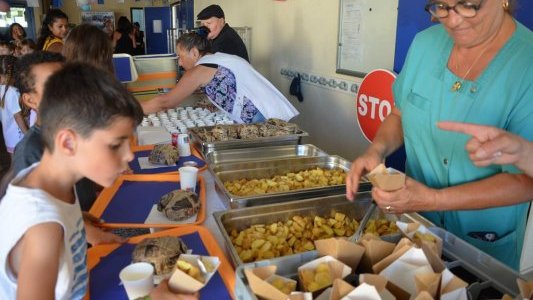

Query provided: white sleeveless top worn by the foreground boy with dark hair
[0,163,88,299]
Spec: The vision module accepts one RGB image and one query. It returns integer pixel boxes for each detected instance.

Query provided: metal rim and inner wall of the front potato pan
[213,192,431,266]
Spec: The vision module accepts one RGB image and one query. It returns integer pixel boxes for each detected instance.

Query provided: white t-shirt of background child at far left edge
[0,85,24,152]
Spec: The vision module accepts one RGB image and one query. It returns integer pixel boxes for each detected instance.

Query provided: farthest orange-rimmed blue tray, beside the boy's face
[128,145,207,174]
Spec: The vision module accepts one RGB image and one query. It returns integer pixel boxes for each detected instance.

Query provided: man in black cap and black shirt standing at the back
[196,4,250,61]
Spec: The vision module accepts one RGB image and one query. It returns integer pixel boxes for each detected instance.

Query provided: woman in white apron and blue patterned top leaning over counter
[142,33,298,123]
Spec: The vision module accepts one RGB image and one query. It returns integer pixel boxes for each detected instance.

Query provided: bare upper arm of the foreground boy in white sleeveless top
[16,223,63,299]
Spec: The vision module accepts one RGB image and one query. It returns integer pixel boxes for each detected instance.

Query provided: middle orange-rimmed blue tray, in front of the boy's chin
[90,174,207,228]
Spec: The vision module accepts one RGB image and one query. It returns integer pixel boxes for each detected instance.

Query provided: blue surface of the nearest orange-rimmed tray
[89,232,231,300]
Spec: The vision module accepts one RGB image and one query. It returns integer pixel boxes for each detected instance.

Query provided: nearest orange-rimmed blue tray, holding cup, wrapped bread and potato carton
[85,225,236,299]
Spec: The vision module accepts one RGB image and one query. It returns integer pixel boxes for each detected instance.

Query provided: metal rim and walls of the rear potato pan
[210,155,371,208]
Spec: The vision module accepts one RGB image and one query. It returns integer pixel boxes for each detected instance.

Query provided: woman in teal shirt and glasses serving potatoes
[347,0,533,269]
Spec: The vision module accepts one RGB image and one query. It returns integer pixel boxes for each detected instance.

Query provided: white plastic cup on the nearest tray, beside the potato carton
[118,262,154,300]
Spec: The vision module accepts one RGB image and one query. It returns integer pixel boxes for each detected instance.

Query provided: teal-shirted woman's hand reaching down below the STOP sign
[346,146,383,201]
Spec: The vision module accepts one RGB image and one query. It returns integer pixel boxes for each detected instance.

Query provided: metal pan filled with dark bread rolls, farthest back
[189,125,309,156]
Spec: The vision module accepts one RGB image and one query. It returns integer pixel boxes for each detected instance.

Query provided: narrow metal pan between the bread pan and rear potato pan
[205,144,328,165]
